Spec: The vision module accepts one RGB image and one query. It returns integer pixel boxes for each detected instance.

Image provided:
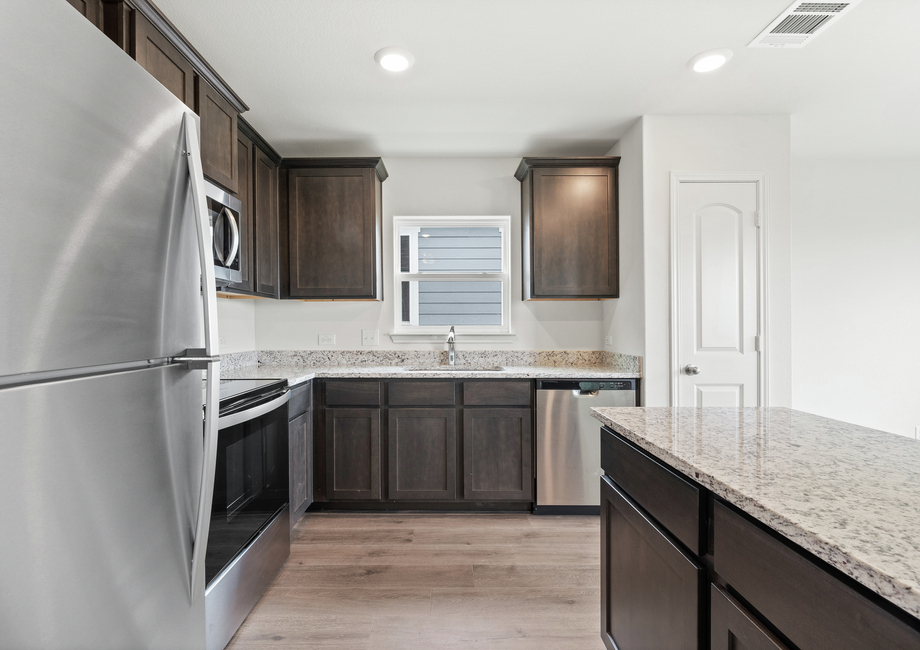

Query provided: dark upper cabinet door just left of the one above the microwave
[133,11,194,109]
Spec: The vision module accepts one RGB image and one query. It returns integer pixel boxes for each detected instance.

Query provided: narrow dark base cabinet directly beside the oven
[288,382,313,528]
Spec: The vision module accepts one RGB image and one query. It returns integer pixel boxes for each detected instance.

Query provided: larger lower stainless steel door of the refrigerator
[0,365,205,650]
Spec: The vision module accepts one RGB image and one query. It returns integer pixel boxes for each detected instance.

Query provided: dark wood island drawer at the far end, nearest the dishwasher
[601,427,706,555]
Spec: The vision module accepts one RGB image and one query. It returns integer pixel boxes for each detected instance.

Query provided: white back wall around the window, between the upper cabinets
[254,158,603,350]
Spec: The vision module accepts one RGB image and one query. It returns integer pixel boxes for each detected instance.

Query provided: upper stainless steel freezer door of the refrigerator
[0,0,204,377]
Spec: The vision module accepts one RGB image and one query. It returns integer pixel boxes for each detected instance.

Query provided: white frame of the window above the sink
[391,215,513,343]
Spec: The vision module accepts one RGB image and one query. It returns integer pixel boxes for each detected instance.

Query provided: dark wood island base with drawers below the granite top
[601,427,920,650]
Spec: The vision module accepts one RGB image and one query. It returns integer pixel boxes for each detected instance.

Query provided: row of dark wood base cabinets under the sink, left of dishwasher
[317,379,534,509]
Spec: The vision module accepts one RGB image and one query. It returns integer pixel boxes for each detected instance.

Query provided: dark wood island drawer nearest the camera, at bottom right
[713,501,920,650]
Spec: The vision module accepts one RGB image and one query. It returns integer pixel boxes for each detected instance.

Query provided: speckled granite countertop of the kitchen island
[591,407,920,618]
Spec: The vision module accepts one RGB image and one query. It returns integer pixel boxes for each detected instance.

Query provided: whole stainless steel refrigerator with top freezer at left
[0,0,218,650]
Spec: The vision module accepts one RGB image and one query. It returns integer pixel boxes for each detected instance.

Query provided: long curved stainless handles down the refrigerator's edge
[182,113,220,602]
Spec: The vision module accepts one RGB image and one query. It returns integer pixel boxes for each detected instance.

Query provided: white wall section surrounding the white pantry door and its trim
[642,115,792,406]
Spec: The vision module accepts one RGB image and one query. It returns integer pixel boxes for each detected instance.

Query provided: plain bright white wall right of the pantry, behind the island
[792,159,920,437]
